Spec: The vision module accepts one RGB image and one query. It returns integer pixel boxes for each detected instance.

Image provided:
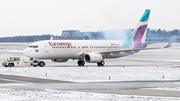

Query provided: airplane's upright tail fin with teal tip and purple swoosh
[130,9,150,49]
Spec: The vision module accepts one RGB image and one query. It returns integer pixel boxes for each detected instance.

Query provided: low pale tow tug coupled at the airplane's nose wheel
[2,56,45,67]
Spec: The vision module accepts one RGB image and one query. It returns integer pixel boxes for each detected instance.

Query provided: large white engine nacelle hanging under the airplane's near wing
[84,53,103,63]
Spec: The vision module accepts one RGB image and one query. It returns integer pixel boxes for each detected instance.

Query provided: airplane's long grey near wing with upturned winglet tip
[99,36,175,54]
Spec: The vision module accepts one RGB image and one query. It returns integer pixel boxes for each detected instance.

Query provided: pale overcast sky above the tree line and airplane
[0,0,180,37]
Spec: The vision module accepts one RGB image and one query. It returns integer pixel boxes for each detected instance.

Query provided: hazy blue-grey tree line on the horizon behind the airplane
[0,29,180,42]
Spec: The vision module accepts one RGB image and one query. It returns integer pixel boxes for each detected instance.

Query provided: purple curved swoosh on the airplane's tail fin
[133,25,147,49]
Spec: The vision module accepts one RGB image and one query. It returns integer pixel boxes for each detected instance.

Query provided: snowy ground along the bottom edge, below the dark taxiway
[0,89,180,101]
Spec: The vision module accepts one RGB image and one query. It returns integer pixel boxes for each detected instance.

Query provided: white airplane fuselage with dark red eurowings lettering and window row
[23,40,132,59]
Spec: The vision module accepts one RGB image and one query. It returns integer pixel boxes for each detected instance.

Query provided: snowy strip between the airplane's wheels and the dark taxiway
[0,66,180,82]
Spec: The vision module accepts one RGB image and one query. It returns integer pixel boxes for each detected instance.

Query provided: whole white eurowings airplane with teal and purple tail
[23,9,174,67]
